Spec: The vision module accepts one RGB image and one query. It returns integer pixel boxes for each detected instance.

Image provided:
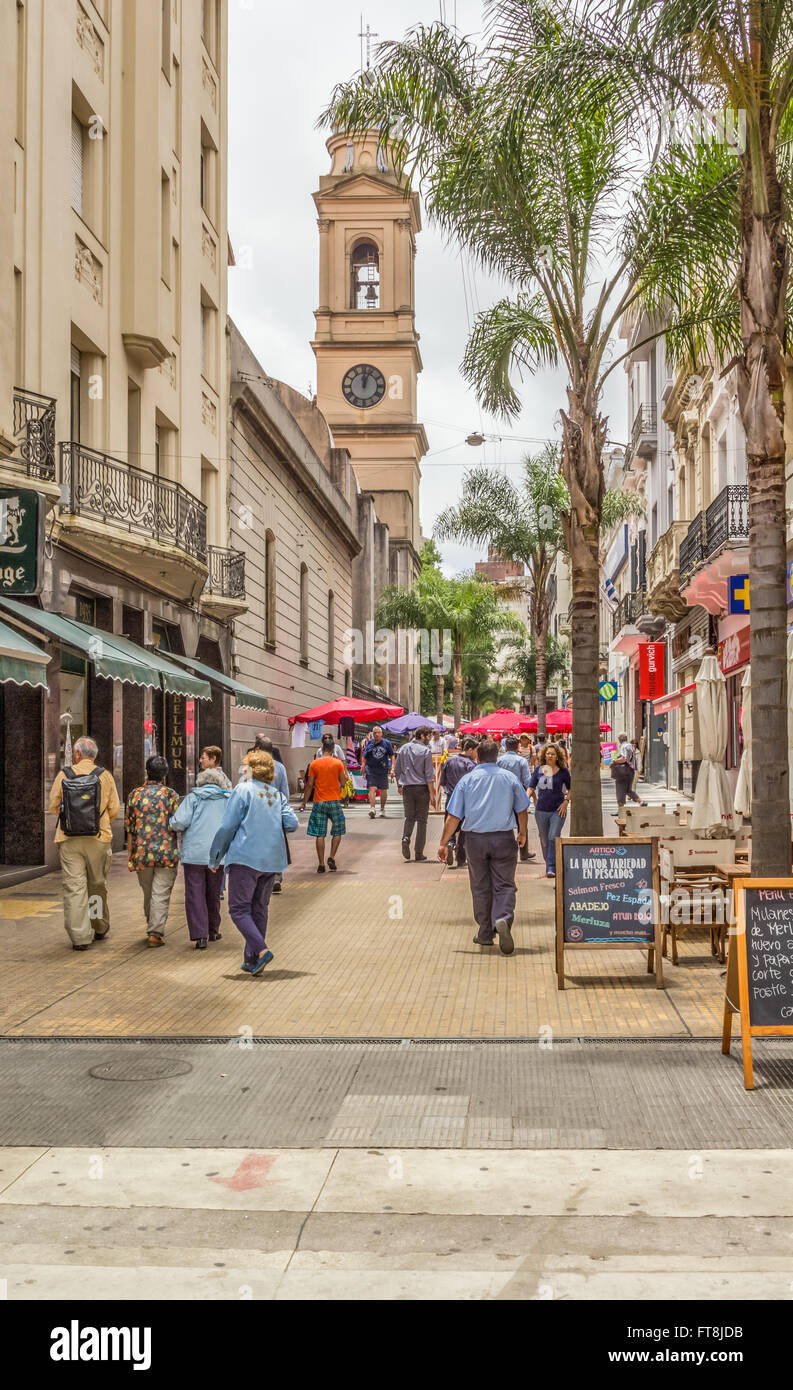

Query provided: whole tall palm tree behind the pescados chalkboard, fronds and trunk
[322,0,715,835]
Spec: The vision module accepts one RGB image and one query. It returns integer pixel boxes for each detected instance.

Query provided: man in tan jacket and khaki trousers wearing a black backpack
[50,738,121,951]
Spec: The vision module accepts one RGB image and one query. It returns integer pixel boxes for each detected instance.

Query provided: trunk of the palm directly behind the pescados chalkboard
[562,382,607,835]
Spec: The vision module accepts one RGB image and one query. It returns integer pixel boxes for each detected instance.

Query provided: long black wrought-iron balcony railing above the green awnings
[60,442,207,563]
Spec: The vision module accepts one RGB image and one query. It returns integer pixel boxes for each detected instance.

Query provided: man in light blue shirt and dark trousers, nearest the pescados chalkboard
[437,738,529,955]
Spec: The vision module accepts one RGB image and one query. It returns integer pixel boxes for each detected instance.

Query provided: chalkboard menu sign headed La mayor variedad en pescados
[556,837,664,990]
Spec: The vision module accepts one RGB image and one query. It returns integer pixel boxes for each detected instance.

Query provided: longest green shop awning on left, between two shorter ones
[0,595,212,699]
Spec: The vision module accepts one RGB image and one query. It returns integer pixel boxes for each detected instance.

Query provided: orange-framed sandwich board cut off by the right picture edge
[721,878,793,1091]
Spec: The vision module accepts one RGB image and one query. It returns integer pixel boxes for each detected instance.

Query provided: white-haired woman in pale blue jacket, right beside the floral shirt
[171,767,231,951]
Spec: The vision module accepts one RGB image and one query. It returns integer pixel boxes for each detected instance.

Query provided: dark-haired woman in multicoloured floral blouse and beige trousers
[125,756,179,947]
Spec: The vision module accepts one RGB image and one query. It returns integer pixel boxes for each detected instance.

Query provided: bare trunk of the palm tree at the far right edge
[737,95,790,878]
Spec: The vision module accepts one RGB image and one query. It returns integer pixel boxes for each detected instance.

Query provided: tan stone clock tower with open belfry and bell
[311,132,428,585]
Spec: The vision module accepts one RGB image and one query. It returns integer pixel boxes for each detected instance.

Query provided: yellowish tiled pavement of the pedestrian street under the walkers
[0,783,724,1038]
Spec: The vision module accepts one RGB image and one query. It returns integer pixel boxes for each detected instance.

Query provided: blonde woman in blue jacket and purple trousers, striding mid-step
[210,748,299,974]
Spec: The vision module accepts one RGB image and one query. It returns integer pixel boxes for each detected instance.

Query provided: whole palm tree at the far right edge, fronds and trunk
[574,0,793,877]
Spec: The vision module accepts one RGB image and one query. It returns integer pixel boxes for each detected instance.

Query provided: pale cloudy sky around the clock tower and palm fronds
[229,0,626,574]
